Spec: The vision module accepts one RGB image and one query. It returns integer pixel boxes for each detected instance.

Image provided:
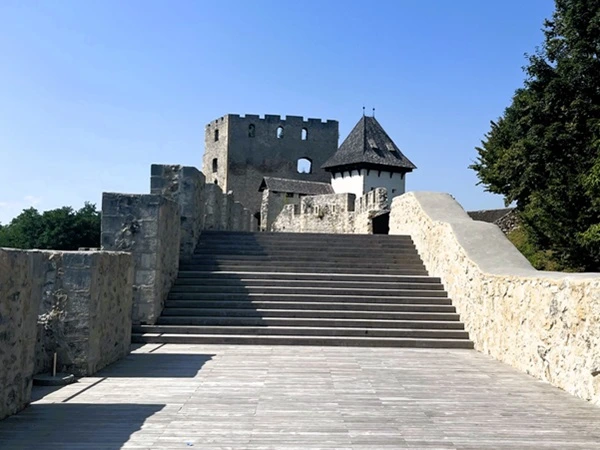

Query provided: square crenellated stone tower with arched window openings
[202,114,339,214]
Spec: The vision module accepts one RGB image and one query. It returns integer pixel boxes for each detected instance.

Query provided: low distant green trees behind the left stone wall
[0,202,100,250]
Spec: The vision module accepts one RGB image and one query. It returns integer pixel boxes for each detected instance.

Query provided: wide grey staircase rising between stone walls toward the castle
[132,232,473,348]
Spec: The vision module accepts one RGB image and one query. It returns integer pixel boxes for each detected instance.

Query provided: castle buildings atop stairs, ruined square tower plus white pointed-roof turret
[203,114,416,231]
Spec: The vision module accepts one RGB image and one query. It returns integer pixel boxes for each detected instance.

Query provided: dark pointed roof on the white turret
[321,116,417,172]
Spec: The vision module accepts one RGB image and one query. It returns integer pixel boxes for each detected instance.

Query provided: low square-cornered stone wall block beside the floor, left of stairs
[35,252,133,376]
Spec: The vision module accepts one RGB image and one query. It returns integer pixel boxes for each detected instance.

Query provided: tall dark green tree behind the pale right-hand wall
[470,0,600,270]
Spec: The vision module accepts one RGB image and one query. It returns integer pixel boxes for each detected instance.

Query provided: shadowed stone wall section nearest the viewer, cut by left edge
[0,249,42,420]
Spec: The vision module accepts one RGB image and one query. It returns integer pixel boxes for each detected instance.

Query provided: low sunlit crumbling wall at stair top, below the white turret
[271,188,389,234]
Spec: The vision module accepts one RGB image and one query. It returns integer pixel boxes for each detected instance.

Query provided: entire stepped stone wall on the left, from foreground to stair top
[0,165,256,422]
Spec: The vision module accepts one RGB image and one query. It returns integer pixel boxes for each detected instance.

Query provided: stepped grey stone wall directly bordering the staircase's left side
[101,164,256,325]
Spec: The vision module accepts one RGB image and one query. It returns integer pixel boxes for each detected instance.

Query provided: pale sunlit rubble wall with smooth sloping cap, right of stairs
[390,192,600,404]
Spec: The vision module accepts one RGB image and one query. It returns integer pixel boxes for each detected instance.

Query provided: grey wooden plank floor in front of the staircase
[0,344,600,450]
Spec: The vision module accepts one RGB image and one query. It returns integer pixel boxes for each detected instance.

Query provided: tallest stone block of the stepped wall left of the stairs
[150,164,206,259]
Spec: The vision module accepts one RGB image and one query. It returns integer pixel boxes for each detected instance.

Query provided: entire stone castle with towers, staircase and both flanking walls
[0,109,600,419]
